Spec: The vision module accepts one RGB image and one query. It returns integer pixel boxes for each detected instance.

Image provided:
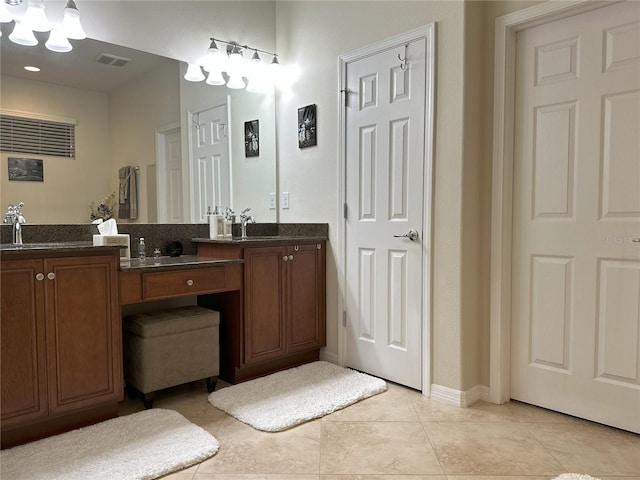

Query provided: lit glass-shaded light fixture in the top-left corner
[0,0,87,52]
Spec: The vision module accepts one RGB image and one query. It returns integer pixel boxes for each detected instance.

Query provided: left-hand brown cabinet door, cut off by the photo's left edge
[0,260,47,427]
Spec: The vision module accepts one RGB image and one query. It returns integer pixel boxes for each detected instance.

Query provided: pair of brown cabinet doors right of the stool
[244,244,325,364]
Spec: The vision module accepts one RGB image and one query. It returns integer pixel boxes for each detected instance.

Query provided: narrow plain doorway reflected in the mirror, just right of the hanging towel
[156,124,184,223]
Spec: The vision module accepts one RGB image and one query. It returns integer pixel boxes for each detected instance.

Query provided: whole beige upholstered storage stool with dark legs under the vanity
[123,306,220,408]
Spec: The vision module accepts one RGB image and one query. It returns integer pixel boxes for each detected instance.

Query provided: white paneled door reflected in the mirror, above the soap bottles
[191,103,231,222]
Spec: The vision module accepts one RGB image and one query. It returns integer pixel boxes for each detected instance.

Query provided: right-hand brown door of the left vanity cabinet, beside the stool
[44,255,122,414]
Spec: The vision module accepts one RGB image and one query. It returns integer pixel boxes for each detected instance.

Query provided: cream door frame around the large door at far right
[489,0,618,403]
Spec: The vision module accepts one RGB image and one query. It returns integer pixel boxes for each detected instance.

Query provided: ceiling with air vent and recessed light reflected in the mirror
[0,23,175,92]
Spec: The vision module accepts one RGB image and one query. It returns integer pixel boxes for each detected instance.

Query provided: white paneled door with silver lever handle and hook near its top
[345,34,426,389]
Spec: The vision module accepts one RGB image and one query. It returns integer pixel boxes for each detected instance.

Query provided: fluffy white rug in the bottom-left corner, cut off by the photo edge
[0,408,219,480]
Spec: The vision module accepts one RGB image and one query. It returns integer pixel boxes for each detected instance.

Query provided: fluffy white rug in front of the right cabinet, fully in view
[209,362,387,432]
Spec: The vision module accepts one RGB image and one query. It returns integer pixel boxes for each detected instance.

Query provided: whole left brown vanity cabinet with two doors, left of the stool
[0,250,123,447]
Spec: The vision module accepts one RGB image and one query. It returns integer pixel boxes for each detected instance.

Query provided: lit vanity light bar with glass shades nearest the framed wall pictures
[184,38,280,92]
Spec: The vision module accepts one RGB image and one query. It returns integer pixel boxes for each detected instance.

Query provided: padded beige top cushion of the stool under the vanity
[124,306,220,337]
